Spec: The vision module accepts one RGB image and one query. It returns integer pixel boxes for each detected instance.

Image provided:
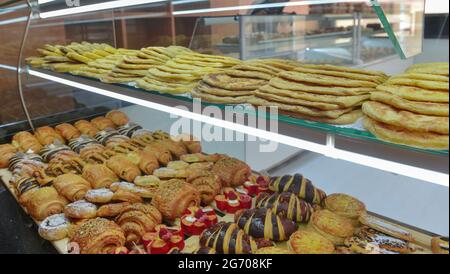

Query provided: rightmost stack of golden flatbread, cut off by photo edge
[363,63,449,149]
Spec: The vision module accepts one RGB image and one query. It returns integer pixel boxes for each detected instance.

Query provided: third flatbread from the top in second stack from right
[269,77,375,96]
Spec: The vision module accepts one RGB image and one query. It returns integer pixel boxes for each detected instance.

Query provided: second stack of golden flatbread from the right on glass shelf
[249,64,387,125]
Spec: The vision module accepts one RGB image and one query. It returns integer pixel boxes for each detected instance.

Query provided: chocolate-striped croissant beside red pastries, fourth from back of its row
[200,222,258,254]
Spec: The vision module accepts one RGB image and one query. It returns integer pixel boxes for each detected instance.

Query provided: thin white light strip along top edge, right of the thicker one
[173,0,370,15]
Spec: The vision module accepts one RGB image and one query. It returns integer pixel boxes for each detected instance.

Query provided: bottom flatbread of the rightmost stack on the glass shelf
[364,117,449,149]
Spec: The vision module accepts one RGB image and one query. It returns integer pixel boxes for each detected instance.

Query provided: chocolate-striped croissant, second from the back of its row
[256,192,313,223]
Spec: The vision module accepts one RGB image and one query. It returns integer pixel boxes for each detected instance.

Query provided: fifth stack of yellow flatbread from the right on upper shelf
[101,46,190,83]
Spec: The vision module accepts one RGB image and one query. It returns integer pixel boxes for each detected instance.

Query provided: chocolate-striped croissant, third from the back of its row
[235,208,296,241]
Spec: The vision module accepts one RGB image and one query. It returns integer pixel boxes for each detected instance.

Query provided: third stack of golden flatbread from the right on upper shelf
[192,59,298,104]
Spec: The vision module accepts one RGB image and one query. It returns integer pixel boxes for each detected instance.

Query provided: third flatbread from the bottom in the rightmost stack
[370,92,449,116]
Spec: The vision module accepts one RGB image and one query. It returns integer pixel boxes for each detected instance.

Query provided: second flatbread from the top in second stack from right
[278,71,377,88]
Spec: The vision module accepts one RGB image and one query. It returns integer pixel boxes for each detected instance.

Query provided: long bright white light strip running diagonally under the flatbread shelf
[28,70,449,187]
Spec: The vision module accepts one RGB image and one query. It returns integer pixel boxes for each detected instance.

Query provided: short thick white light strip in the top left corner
[39,0,168,18]
